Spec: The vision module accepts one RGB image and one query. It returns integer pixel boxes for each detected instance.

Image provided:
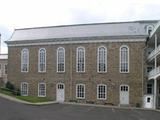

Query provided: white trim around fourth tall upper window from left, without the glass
[76,46,86,73]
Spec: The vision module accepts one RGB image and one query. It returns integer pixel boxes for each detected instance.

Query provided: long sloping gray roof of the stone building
[10,21,157,41]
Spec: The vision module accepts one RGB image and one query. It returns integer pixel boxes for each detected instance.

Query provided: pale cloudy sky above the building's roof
[0,0,160,53]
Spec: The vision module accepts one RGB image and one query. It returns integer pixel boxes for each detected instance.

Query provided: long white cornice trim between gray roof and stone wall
[8,39,146,47]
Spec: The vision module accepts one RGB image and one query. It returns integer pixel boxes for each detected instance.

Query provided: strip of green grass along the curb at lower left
[0,88,52,103]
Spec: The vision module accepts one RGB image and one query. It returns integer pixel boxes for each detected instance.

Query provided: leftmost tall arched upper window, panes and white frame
[21,48,29,72]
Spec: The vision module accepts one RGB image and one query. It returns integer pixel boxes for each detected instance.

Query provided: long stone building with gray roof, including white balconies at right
[6,20,160,108]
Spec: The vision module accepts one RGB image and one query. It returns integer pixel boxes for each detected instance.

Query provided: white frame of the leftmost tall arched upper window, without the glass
[21,48,29,72]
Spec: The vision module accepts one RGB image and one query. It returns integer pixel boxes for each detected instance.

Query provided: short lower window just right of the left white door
[76,84,85,99]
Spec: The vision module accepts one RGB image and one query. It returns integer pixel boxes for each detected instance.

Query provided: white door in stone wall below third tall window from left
[56,83,65,102]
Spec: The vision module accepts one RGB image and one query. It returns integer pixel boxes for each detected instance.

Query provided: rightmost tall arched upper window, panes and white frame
[120,46,129,73]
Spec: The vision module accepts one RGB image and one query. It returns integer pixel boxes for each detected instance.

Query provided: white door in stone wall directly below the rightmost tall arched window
[120,85,129,105]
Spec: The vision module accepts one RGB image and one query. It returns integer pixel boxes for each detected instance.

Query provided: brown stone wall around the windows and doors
[8,42,145,106]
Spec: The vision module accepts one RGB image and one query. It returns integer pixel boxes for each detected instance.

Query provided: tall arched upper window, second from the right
[97,47,107,72]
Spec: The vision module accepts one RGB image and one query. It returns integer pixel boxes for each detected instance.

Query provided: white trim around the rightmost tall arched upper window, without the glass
[119,45,130,73]
